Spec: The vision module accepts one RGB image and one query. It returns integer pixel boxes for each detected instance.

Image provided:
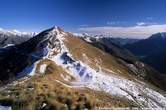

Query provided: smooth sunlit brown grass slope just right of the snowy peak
[65,33,140,81]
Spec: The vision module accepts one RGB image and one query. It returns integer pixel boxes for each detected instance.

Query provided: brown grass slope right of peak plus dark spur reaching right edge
[65,33,166,91]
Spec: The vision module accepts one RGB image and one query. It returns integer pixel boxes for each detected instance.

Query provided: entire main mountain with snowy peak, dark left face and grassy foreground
[0,27,166,110]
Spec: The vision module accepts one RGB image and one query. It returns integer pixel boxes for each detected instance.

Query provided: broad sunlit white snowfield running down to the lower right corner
[87,70,166,107]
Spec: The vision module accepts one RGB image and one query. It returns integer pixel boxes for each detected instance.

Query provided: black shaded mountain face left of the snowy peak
[0,27,53,82]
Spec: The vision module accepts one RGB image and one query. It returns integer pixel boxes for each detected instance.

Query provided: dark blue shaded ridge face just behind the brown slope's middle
[80,36,137,63]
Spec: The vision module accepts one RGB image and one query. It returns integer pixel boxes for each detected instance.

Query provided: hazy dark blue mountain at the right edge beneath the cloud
[125,33,166,73]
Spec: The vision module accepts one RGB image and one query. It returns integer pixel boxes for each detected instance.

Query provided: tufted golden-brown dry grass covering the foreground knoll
[0,59,135,110]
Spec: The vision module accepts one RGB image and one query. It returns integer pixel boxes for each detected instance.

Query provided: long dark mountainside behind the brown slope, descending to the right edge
[81,35,165,91]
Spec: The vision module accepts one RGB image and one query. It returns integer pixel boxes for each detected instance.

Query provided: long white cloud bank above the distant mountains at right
[79,24,166,38]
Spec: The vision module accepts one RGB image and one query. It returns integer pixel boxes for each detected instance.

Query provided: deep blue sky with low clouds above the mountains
[0,0,166,38]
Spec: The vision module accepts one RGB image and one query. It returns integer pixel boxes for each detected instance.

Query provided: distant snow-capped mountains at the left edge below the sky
[0,29,36,47]
